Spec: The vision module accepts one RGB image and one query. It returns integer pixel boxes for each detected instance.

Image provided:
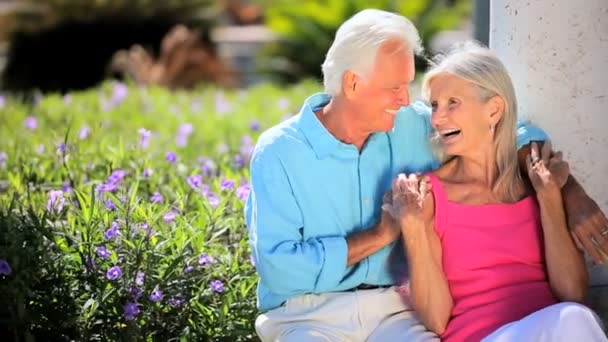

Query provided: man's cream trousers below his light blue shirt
[255,286,439,342]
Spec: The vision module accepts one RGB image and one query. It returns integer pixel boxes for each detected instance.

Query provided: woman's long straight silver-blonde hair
[422,42,523,202]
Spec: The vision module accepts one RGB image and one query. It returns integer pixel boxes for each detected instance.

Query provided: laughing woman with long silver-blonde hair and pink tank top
[384,44,606,341]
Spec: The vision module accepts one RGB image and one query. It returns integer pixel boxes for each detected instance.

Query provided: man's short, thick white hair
[322,9,422,96]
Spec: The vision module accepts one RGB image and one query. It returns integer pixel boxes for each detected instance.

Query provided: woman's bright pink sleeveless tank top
[430,174,557,342]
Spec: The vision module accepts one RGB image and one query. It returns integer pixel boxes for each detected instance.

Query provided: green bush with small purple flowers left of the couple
[0,82,318,341]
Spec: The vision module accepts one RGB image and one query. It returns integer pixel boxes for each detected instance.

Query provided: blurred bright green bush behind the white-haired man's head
[263,0,471,82]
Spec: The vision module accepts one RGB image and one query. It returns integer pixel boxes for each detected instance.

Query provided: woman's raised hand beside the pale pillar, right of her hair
[526,142,570,195]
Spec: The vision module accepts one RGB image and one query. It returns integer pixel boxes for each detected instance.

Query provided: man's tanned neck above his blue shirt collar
[315,99,371,151]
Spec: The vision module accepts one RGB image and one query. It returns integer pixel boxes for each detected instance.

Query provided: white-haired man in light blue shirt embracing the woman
[245,10,605,341]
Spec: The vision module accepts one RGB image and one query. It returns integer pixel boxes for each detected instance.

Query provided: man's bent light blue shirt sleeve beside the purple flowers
[245,146,347,295]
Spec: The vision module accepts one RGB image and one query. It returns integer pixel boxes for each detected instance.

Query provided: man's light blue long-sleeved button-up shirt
[245,93,547,310]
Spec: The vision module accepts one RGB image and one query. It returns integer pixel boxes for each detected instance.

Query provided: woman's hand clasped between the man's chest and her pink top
[382,174,435,228]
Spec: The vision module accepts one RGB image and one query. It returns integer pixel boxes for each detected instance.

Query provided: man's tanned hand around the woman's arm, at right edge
[564,177,608,264]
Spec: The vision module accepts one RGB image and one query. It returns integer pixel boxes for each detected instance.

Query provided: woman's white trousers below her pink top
[482,302,608,342]
